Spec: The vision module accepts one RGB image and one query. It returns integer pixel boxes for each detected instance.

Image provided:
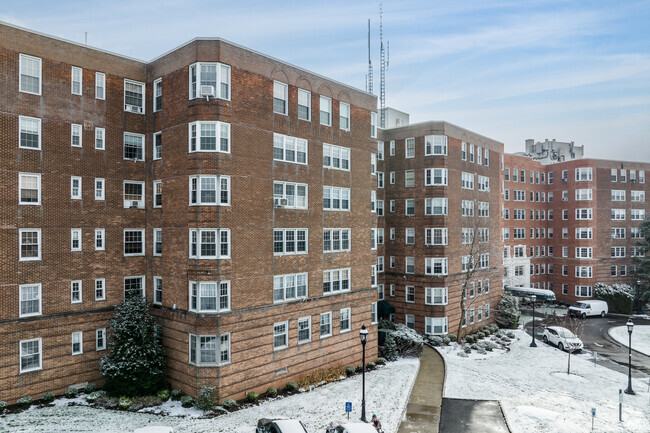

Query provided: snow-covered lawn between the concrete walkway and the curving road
[438,329,650,433]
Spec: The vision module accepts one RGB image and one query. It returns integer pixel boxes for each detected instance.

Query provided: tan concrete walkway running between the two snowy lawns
[398,346,445,433]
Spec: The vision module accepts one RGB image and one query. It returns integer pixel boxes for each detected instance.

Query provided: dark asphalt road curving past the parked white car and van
[526,315,650,380]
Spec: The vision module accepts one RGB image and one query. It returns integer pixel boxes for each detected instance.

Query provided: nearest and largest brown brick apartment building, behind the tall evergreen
[0,25,377,402]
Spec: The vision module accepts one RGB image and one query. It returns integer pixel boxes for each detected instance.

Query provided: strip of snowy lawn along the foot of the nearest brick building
[0,358,420,433]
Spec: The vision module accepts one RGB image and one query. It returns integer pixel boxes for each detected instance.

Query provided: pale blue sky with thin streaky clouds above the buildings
[0,0,650,161]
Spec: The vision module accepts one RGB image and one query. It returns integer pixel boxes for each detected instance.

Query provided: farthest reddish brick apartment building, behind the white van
[502,146,650,303]
